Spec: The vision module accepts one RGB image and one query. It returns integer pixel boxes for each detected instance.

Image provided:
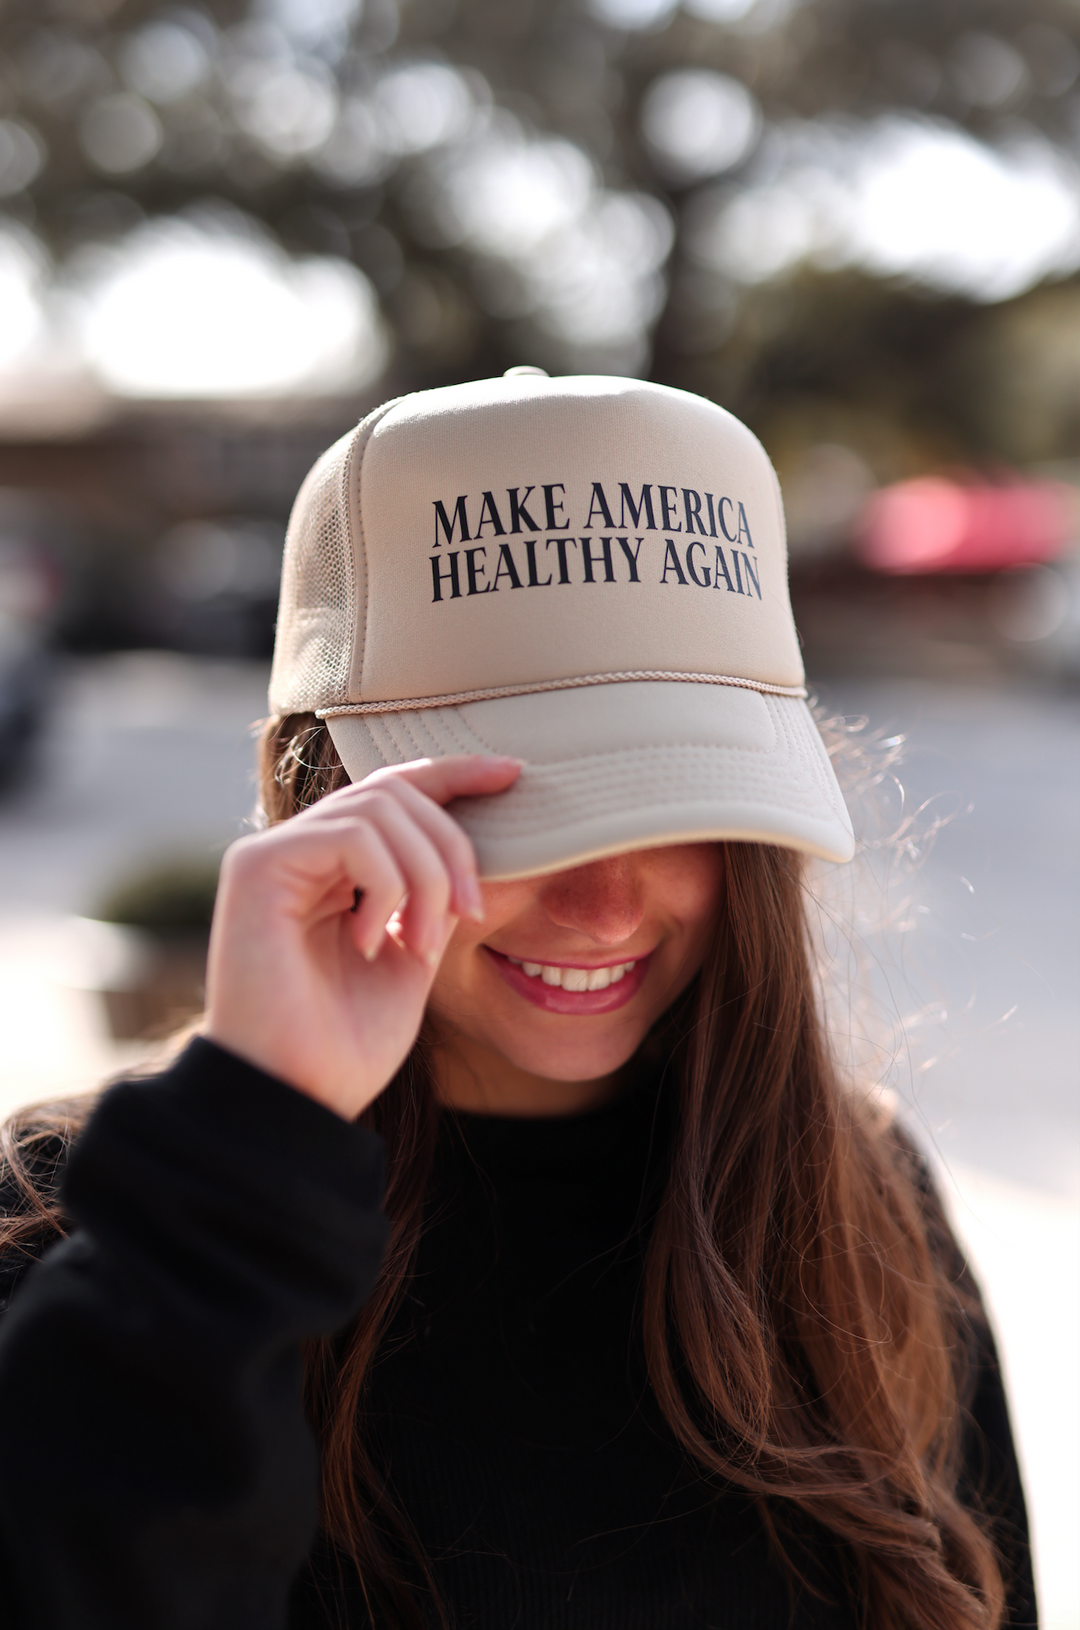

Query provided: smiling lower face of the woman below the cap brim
[428,843,723,1115]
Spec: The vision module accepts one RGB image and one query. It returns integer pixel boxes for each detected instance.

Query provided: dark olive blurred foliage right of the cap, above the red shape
[656,267,1080,481]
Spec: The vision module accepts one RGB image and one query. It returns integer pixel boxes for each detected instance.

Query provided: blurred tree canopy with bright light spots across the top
[0,0,1080,474]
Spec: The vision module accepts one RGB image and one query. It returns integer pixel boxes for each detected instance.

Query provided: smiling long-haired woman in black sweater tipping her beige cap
[0,370,1034,1630]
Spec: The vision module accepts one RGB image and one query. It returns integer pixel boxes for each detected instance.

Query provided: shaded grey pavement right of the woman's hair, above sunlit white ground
[821,681,1080,1200]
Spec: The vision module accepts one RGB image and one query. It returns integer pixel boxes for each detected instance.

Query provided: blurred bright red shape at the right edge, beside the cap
[858,476,1077,577]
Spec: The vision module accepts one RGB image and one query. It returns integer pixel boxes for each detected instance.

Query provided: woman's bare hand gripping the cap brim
[205,755,521,1120]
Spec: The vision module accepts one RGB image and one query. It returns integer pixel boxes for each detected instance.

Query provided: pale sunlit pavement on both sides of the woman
[0,654,1080,1630]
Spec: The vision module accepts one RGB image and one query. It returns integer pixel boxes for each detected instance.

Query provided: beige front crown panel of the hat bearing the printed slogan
[350,377,803,706]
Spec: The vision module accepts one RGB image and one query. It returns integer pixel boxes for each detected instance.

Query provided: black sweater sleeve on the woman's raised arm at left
[0,1040,386,1630]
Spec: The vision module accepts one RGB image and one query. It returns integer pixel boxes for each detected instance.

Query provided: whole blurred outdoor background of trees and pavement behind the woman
[0,0,1080,1630]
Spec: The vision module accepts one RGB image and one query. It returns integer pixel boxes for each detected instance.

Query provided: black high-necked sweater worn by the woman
[0,1042,1034,1630]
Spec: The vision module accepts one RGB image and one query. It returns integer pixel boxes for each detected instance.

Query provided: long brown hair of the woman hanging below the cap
[7,714,1003,1630]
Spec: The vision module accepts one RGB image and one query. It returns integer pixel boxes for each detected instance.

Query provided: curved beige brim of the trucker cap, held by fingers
[326,680,855,882]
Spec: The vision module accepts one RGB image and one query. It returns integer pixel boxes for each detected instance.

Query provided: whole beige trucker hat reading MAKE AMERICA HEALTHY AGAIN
[270,370,854,879]
